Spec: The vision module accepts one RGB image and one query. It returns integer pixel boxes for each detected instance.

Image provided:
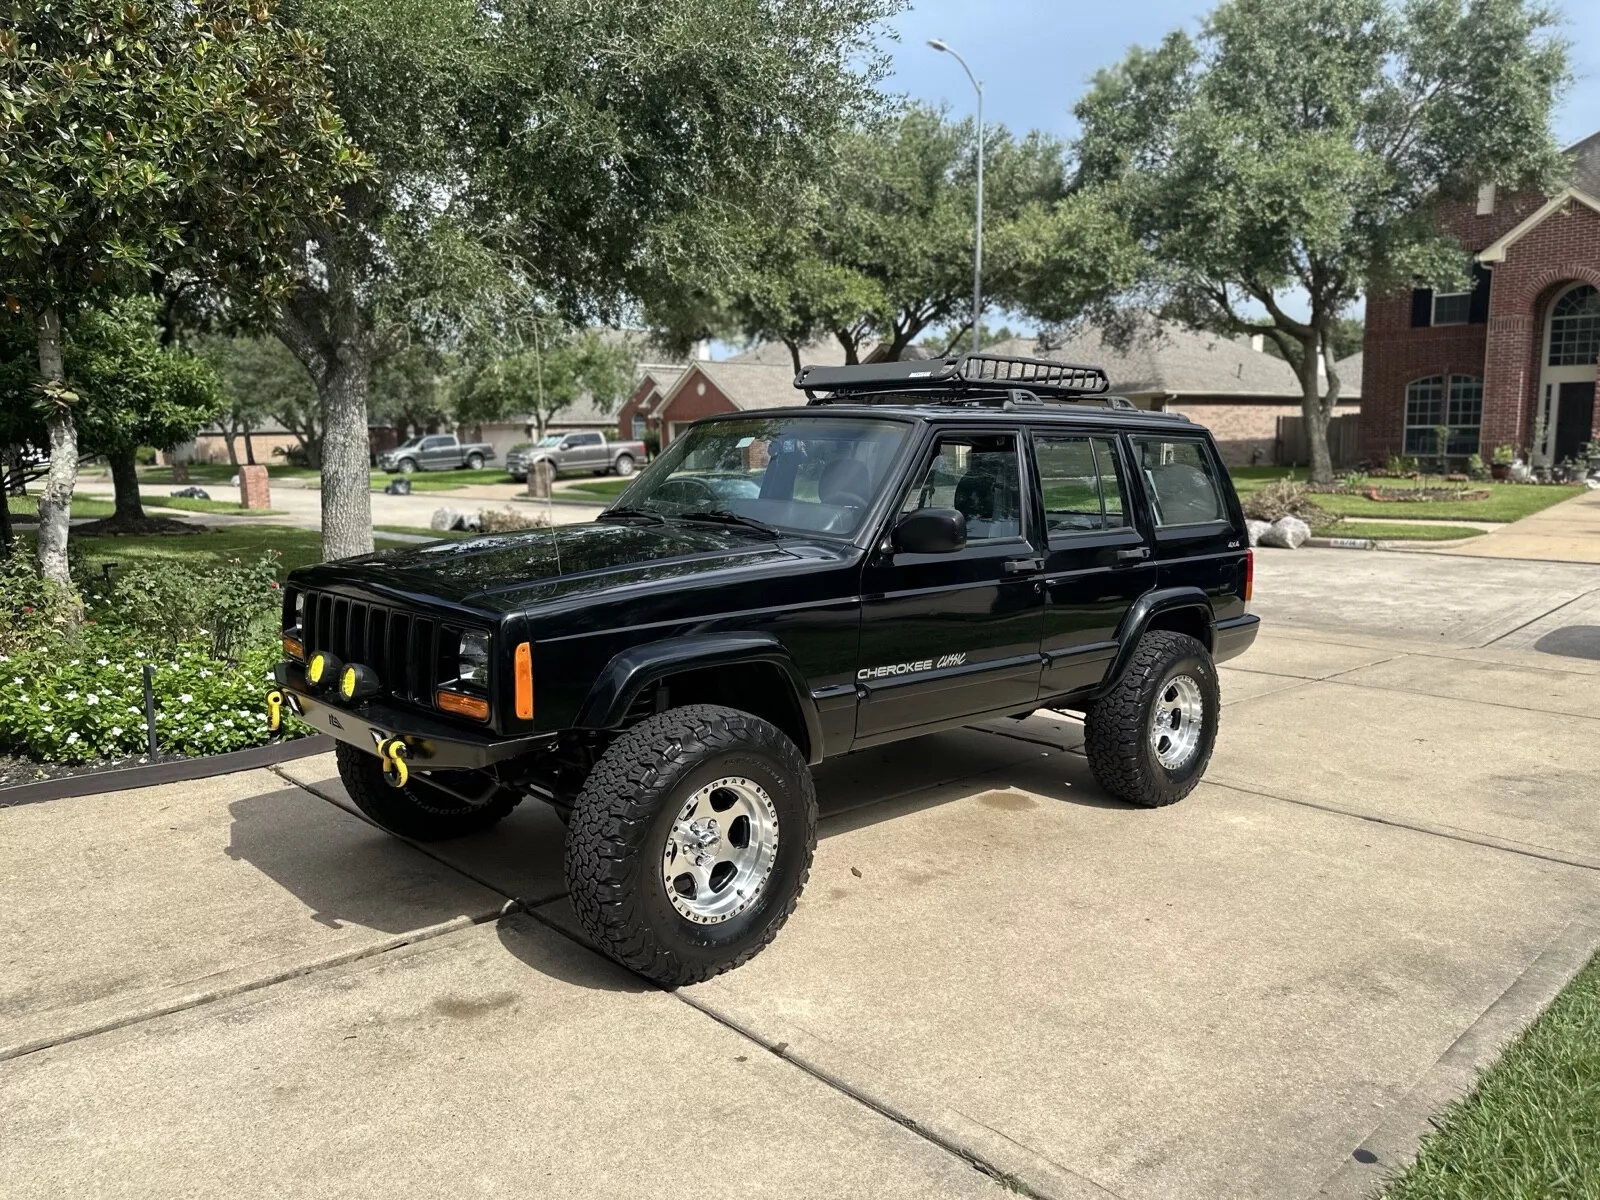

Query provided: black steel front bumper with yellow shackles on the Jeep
[274,662,555,771]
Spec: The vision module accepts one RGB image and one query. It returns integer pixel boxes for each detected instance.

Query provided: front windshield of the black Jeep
[618,416,909,538]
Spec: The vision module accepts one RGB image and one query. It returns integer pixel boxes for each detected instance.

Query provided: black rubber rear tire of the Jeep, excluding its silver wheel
[1083,629,1222,808]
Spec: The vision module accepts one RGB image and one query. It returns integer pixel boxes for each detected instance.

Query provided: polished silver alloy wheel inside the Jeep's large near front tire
[661,776,778,925]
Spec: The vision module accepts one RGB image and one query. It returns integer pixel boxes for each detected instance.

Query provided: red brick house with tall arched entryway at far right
[1362,133,1600,466]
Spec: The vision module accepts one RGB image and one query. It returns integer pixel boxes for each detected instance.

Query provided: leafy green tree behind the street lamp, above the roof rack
[651,104,1066,370]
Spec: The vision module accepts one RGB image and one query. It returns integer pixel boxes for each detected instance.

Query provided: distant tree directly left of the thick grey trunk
[197,334,322,467]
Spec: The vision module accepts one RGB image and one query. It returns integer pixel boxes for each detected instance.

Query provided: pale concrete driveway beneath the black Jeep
[0,550,1600,1200]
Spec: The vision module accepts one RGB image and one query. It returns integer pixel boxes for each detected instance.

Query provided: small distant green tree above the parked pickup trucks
[456,330,637,438]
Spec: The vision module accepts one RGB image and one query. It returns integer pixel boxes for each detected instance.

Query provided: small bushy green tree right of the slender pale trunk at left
[72,299,226,528]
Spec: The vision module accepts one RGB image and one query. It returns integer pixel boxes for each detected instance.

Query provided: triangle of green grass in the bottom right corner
[1384,957,1600,1200]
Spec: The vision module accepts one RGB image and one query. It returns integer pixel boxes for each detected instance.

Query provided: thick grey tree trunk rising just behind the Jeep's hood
[317,350,373,558]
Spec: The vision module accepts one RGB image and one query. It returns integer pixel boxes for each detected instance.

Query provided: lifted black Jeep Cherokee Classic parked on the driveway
[272,355,1258,984]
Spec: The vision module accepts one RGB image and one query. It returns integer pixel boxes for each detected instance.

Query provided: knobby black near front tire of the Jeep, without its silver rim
[566,704,816,987]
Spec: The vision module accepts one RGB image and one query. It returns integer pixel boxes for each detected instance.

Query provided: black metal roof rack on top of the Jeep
[795,354,1131,408]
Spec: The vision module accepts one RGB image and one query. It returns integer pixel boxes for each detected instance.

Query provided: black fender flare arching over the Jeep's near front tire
[576,634,822,763]
